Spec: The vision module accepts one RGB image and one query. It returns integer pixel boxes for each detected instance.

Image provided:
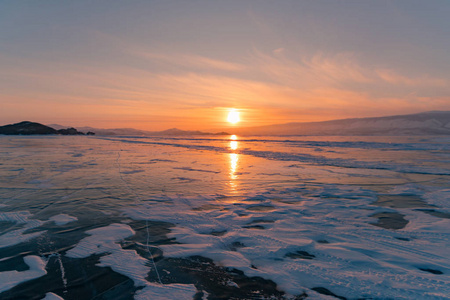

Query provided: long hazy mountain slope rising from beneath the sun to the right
[233,111,450,136]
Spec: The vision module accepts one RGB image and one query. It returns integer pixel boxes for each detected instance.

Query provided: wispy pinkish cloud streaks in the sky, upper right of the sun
[254,48,450,88]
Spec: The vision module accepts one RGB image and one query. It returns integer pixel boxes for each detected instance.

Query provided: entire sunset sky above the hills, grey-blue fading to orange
[0,0,450,130]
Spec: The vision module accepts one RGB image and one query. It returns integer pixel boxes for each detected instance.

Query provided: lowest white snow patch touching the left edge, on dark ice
[0,255,47,292]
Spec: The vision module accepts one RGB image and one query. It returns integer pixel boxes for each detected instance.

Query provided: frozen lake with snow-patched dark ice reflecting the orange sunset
[0,136,450,300]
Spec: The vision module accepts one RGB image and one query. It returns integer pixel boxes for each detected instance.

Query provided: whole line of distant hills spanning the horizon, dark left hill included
[0,111,450,136]
